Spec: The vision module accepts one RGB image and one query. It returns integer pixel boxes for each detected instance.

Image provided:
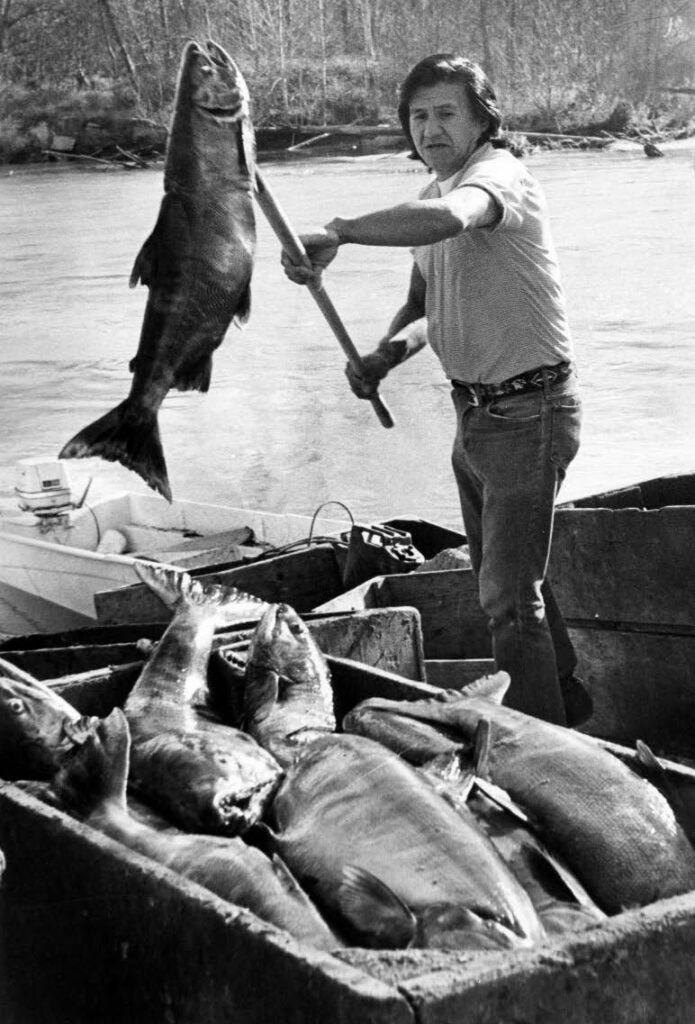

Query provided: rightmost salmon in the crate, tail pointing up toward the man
[348,673,695,913]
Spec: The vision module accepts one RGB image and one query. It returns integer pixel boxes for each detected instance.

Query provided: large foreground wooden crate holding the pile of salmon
[0,658,695,1024]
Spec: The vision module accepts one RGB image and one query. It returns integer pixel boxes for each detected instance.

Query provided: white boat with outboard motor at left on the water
[0,460,350,635]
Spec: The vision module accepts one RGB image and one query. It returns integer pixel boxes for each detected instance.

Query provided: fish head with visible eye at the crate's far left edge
[0,677,80,780]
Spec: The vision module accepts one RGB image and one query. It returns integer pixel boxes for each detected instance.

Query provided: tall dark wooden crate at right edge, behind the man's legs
[549,475,695,754]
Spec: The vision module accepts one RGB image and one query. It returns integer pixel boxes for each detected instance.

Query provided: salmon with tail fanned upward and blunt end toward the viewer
[125,563,280,835]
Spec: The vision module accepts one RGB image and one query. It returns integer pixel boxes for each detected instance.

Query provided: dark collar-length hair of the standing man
[398,53,505,160]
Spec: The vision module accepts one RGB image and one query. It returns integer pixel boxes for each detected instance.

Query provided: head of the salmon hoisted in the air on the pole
[178,41,251,123]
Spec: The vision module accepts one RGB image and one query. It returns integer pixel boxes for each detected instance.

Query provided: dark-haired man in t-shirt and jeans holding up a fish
[283,53,591,724]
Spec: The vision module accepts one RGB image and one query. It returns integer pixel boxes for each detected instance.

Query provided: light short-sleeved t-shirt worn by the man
[412,142,573,384]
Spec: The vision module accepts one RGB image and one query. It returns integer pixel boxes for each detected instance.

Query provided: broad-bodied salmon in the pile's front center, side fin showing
[269,733,544,949]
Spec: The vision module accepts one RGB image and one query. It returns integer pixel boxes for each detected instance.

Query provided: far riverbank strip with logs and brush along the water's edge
[0,83,695,168]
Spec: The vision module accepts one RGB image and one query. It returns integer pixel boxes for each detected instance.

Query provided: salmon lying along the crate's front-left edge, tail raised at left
[53,708,341,949]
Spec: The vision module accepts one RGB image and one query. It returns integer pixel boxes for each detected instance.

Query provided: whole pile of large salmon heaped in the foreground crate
[0,565,695,950]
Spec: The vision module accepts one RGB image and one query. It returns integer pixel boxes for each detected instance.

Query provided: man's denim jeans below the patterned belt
[451,373,581,725]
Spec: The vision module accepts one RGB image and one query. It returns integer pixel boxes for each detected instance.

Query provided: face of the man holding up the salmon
[409,82,485,179]
